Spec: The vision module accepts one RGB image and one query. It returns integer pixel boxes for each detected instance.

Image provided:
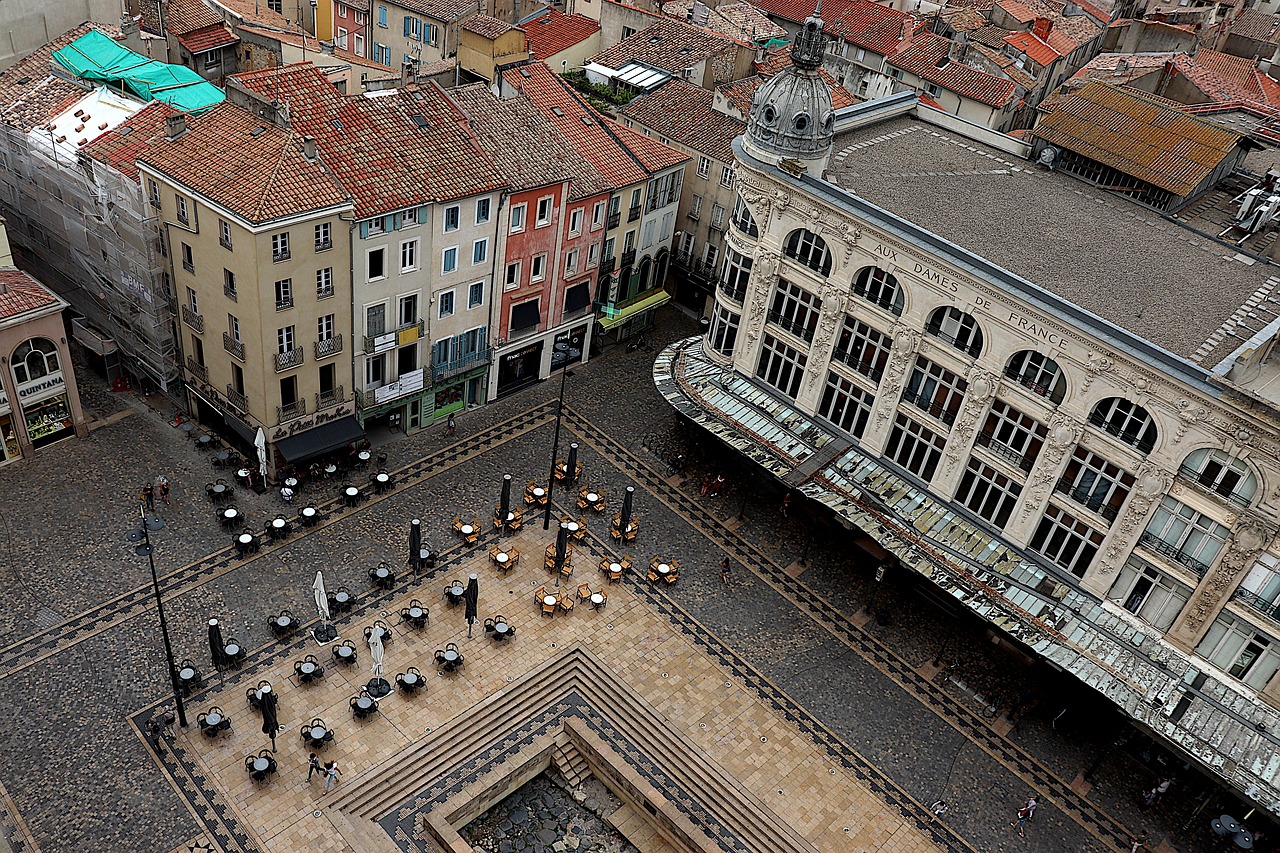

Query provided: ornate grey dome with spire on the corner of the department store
[746,9,836,160]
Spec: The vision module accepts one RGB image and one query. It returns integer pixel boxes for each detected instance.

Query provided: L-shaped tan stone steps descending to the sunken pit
[328,648,817,853]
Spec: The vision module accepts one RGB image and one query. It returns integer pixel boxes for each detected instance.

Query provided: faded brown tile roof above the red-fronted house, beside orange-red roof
[449,83,607,200]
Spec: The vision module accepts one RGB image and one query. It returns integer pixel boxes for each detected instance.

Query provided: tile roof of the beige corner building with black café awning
[138,101,347,223]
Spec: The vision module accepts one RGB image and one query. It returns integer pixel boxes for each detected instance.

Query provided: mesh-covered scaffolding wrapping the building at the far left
[0,78,182,391]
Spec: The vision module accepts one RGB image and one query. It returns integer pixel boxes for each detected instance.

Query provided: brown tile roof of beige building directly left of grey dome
[622,78,742,163]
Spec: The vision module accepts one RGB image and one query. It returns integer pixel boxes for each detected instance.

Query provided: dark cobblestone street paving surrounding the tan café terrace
[0,311,1234,853]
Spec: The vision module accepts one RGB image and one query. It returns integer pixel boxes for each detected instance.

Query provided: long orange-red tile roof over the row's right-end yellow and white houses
[503,63,689,190]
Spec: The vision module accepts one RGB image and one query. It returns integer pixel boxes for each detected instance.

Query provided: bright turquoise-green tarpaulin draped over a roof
[54,29,227,113]
